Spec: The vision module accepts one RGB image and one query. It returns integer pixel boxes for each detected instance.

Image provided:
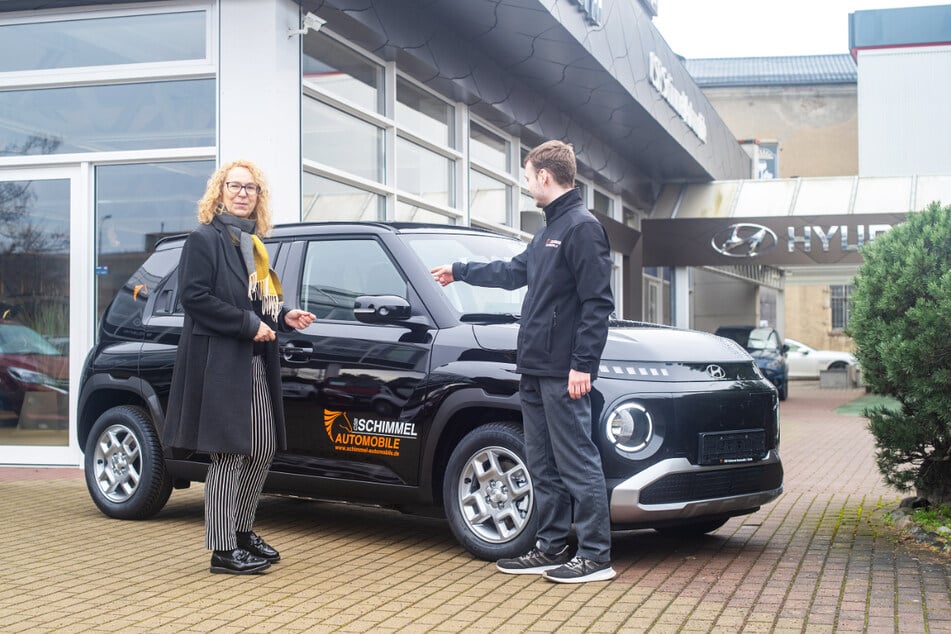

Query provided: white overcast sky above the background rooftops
[654,0,951,58]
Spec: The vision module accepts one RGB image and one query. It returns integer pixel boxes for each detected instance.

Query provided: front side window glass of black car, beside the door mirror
[300,239,407,321]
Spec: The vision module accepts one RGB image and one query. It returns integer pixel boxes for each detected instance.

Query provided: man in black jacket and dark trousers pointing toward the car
[432,141,615,583]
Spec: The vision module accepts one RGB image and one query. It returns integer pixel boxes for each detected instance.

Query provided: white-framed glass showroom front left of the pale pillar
[0,6,212,464]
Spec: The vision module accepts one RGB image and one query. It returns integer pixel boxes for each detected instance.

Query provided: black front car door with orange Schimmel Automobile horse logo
[273,236,432,484]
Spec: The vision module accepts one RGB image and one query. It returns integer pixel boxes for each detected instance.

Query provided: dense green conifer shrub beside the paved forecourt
[847,203,951,504]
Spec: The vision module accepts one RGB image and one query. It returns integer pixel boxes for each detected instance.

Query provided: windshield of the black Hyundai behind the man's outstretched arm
[403,233,527,315]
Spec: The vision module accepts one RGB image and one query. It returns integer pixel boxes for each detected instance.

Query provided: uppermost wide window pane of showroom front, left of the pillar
[0,11,205,72]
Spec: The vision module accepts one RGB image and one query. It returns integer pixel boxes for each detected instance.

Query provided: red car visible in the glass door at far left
[0,320,69,429]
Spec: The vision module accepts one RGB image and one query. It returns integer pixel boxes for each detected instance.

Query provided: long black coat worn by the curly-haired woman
[162,219,291,455]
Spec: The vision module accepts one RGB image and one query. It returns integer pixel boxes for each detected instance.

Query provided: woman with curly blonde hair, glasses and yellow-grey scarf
[162,161,316,574]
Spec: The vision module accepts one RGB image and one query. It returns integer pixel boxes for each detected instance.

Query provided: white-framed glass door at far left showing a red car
[0,168,84,466]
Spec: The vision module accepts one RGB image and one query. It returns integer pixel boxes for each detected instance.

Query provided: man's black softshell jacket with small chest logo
[452,189,614,379]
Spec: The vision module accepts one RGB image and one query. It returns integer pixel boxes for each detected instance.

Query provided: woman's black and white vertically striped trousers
[205,356,277,550]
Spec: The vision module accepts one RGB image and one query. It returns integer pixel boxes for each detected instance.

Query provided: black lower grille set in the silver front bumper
[640,463,783,504]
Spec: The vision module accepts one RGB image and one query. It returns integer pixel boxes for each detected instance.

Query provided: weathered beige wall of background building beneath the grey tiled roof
[704,85,858,178]
